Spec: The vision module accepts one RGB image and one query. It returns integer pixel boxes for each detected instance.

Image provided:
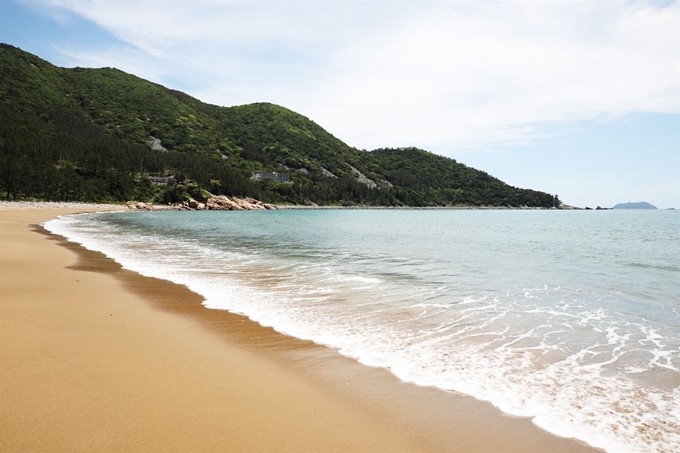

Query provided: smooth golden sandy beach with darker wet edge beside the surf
[0,206,595,452]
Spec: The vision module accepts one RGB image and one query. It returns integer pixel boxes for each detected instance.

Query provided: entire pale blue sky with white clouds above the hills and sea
[0,0,680,209]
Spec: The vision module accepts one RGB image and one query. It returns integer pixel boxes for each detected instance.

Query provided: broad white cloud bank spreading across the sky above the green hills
[21,0,680,153]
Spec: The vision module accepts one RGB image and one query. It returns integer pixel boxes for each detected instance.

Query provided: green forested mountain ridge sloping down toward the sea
[0,44,559,207]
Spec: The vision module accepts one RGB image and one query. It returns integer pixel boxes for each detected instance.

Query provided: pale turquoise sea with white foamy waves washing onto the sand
[45,209,680,453]
